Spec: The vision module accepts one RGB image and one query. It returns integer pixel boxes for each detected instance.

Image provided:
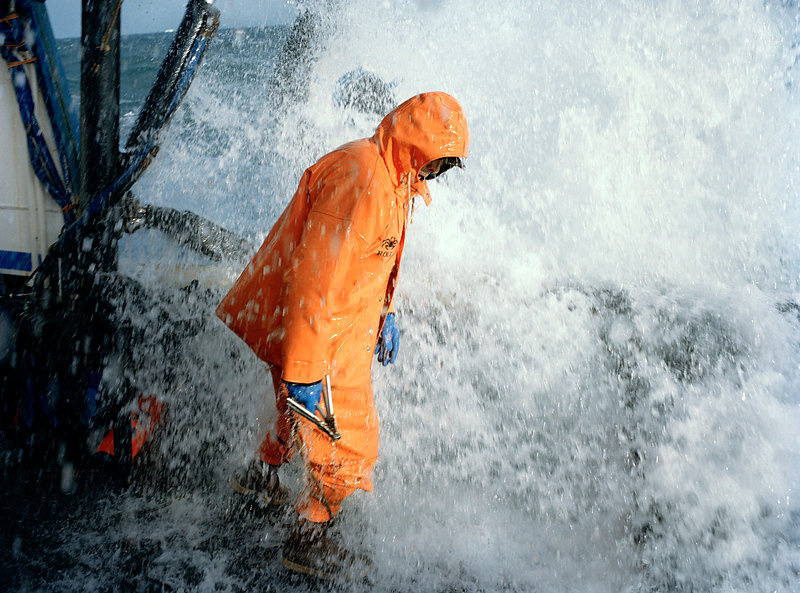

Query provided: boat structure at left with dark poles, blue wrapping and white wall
[0,0,250,473]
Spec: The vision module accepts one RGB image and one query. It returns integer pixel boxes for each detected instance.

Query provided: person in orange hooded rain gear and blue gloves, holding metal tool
[217,92,469,575]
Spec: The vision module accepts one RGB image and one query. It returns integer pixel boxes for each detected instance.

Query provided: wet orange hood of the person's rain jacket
[372,92,469,204]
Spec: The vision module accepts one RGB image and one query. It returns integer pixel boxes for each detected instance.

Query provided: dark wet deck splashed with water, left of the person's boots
[0,462,360,591]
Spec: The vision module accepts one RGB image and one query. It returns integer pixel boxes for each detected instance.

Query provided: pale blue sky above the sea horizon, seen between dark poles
[45,0,297,37]
